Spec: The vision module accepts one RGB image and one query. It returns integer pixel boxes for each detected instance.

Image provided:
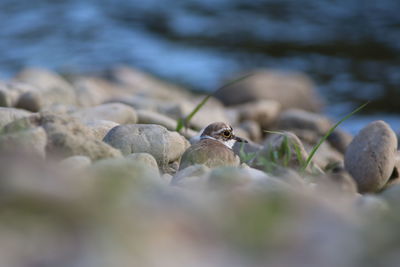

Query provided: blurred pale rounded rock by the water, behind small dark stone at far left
[15,68,76,106]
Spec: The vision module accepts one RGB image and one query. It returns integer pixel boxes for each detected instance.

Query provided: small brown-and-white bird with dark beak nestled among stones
[179,122,247,170]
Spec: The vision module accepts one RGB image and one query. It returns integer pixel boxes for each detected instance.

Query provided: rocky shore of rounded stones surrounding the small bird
[0,67,400,266]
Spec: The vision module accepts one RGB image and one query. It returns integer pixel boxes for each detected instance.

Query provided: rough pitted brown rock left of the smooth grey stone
[4,113,121,160]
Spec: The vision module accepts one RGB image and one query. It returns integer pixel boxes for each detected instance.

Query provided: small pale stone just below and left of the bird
[171,164,210,188]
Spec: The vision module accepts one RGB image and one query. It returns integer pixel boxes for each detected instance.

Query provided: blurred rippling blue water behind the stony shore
[0,0,400,132]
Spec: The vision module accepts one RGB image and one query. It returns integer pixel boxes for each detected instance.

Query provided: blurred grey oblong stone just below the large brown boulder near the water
[277,109,332,136]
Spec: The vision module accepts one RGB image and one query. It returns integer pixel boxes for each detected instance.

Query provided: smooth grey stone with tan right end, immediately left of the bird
[104,124,189,170]
